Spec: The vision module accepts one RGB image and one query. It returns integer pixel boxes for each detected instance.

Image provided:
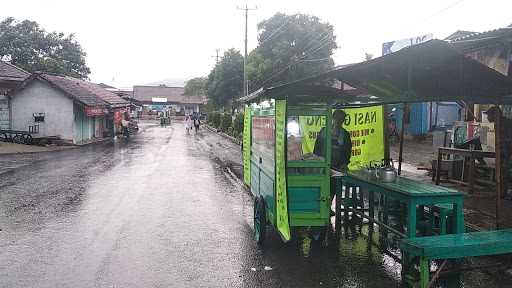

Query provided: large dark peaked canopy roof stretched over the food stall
[240,40,512,105]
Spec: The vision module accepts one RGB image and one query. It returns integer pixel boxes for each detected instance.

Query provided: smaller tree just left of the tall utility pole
[207,49,244,107]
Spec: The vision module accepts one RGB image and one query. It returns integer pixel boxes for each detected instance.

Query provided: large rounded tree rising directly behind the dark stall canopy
[247,13,338,91]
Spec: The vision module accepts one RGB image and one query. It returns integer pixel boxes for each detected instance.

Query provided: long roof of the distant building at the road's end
[133,86,206,104]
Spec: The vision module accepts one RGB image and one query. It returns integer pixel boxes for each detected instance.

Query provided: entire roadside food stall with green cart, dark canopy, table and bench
[242,40,512,287]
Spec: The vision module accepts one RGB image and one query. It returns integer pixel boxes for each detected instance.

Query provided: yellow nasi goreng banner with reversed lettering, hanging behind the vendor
[299,106,384,170]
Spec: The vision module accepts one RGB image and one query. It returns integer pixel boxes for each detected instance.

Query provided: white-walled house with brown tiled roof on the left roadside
[10,73,129,144]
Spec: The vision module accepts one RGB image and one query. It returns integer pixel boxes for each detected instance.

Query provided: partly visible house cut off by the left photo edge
[0,60,30,129]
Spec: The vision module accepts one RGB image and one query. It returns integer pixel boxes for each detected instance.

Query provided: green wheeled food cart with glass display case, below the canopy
[245,100,331,243]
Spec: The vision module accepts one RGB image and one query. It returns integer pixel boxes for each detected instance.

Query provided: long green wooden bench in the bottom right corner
[400,229,512,288]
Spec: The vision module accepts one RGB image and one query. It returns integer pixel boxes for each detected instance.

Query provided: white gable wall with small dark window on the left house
[11,80,74,141]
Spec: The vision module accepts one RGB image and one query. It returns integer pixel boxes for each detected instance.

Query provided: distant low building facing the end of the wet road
[133,85,207,115]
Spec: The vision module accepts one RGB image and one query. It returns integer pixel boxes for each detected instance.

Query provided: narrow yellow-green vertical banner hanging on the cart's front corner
[275,100,291,241]
